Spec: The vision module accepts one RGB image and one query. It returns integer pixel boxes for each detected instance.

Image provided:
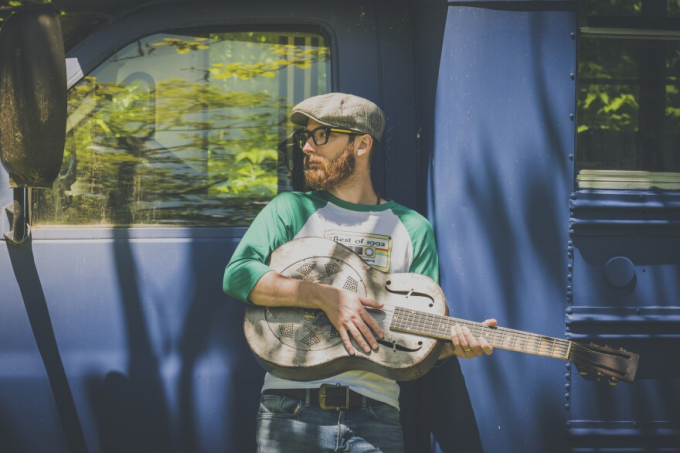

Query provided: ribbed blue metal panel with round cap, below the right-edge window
[567,190,680,452]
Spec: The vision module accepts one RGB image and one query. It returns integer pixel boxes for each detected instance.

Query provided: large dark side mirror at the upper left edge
[0,7,66,188]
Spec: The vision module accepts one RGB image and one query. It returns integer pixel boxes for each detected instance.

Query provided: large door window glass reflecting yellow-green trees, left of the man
[33,31,330,226]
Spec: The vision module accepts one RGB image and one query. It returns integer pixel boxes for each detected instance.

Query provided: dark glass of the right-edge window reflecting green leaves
[577,0,680,171]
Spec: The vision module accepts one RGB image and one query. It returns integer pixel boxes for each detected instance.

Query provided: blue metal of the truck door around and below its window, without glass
[0,1,417,453]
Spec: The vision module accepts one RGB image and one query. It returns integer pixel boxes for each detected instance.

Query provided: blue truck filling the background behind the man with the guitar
[0,0,680,453]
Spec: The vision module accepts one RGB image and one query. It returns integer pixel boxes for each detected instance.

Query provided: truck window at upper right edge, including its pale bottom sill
[576,0,680,189]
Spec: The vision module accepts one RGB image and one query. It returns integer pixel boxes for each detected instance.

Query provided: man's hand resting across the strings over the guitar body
[318,285,384,355]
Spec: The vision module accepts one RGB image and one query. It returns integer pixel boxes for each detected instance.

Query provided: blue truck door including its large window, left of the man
[0,2,416,452]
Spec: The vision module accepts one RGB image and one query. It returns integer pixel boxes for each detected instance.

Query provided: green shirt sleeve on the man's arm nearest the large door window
[222,192,318,302]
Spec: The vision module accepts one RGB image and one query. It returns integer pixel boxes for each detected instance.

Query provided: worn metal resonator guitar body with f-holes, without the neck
[244,238,447,381]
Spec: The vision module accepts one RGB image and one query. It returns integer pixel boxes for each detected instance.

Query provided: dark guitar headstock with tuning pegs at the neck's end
[568,342,640,385]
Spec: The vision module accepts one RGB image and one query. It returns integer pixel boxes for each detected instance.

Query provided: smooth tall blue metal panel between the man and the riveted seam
[430,2,576,452]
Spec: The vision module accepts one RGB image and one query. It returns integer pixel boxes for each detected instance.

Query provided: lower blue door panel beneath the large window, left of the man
[0,238,263,451]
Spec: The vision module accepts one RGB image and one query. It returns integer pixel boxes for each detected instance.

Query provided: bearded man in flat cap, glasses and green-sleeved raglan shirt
[224,93,495,453]
